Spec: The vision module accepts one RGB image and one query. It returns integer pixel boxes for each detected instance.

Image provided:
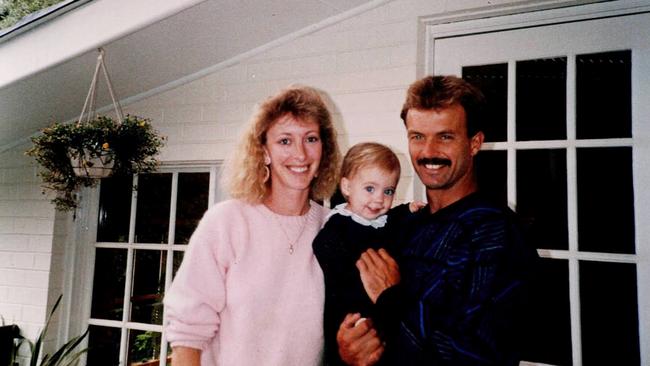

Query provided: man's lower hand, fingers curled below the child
[336,313,384,366]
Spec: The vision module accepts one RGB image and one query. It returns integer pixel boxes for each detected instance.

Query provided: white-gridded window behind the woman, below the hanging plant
[87,166,218,365]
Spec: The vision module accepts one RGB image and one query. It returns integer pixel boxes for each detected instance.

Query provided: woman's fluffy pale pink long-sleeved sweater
[164,200,327,366]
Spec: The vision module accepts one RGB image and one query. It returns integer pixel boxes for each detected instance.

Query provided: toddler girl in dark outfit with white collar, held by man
[313,142,423,365]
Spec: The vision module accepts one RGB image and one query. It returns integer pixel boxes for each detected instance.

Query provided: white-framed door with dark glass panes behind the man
[428,13,650,365]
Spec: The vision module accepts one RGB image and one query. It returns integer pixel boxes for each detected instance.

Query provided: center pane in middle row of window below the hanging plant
[131,250,167,325]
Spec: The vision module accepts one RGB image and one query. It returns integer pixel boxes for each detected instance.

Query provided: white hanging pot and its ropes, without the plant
[69,48,124,178]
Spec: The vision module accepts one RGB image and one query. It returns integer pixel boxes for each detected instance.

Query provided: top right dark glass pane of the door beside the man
[576,51,632,139]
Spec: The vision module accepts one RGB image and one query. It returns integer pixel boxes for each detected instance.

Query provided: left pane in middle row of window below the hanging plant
[90,248,127,320]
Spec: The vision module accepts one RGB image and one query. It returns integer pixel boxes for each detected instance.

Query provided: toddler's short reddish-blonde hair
[341,142,401,180]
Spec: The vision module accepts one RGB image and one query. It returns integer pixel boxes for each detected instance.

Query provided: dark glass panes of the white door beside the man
[462,50,640,365]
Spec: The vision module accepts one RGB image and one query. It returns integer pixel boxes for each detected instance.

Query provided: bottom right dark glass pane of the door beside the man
[580,261,640,365]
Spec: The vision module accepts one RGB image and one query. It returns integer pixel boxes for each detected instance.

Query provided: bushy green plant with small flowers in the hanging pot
[26,115,164,211]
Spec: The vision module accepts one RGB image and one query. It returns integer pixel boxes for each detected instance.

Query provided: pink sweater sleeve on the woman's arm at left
[164,201,237,350]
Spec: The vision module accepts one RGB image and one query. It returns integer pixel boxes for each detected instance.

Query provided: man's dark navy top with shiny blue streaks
[375,193,537,366]
